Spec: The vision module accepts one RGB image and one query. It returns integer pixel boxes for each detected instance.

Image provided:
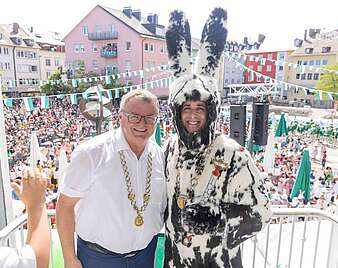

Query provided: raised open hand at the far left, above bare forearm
[11,168,47,209]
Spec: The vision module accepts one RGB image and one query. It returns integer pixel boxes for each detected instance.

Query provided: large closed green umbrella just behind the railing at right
[291,149,311,201]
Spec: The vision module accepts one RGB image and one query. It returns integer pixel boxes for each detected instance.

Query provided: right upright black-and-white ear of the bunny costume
[196,8,228,77]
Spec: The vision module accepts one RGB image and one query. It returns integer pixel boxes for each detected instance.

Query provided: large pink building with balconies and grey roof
[64,5,168,96]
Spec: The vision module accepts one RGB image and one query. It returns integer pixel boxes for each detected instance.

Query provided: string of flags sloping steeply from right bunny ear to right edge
[224,52,338,100]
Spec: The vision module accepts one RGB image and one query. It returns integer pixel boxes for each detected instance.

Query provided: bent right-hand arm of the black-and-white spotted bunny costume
[223,148,271,248]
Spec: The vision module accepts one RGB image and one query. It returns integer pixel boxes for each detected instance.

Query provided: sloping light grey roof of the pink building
[99,5,155,36]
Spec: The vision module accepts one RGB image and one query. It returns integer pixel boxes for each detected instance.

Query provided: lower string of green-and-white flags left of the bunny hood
[0,76,174,112]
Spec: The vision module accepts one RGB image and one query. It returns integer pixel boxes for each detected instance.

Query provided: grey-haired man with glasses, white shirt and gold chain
[56,90,166,268]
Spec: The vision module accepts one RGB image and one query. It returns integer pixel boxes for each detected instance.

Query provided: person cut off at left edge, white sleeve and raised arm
[0,169,50,268]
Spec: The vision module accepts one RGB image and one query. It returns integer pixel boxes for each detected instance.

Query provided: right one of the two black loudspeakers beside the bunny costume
[253,103,269,145]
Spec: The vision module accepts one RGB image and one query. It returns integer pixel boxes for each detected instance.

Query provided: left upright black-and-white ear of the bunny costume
[166,10,192,77]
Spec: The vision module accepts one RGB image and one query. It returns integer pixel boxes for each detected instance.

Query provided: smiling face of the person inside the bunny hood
[181,101,207,133]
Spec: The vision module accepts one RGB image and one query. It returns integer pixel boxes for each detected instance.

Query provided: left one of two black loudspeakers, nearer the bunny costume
[230,105,246,146]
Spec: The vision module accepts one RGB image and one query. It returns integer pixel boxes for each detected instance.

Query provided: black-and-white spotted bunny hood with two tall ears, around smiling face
[166,8,228,150]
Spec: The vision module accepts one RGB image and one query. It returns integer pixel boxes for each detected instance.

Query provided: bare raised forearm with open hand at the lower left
[11,169,50,268]
